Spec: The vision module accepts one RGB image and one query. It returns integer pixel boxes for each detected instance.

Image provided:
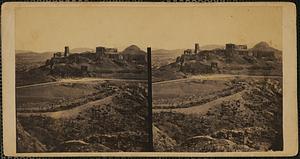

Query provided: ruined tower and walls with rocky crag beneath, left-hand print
[44,46,147,77]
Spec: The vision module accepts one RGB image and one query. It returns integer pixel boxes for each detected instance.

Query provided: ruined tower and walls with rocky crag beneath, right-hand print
[176,43,277,73]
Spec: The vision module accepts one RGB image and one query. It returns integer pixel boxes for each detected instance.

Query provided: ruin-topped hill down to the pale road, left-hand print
[17,45,147,85]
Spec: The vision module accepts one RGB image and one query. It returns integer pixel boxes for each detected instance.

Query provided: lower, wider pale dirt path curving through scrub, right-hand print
[153,90,245,114]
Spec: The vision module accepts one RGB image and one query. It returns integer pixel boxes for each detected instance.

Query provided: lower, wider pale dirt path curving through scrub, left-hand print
[18,96,113,119]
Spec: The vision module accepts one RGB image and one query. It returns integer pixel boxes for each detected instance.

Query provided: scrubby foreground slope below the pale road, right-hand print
[153,77,283,152]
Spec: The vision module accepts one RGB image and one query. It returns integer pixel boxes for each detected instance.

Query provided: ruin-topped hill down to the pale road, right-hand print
[153,42,282,81]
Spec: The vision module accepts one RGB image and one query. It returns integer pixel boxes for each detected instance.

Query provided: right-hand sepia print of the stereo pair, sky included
[152,6,285,152]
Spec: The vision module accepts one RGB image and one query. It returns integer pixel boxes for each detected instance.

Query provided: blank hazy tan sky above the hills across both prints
[15,6,282,52]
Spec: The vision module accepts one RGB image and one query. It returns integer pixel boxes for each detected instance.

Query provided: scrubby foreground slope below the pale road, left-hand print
[17,81,148,152]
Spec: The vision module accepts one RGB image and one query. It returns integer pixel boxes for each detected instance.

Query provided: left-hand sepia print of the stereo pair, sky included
[15,8,149,153]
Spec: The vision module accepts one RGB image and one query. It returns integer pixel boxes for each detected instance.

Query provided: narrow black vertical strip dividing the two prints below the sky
[147,47,153,152]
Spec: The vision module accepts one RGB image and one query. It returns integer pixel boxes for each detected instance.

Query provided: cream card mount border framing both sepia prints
[1,2,298,157]
